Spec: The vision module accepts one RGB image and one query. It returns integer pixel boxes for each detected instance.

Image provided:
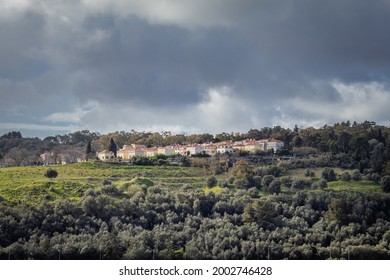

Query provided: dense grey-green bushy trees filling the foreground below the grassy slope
[0,186,390,259]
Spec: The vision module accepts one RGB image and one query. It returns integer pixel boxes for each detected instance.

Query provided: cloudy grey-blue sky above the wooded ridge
[0,0,390,137]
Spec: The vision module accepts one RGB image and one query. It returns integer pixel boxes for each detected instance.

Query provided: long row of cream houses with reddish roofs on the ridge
[97,139,284,161]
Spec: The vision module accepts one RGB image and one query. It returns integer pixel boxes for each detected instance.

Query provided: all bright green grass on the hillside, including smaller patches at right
[0,162,382,204]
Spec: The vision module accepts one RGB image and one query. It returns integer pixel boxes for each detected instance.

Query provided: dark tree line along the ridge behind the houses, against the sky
[0,121,390,175]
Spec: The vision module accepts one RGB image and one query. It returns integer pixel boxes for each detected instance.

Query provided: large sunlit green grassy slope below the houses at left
[0,163,208,204]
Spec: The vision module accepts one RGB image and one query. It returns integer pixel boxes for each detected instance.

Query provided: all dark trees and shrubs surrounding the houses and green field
[0,121,390,259]
